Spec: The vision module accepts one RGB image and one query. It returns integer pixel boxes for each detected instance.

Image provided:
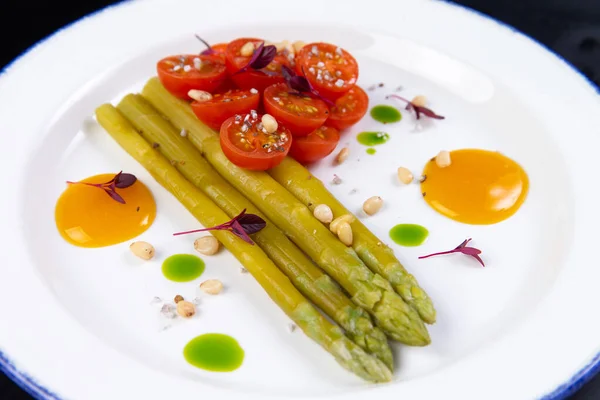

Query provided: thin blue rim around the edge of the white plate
[0,0,600,400]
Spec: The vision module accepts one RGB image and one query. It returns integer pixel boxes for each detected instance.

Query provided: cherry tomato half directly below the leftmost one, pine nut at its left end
[191,89,260,131]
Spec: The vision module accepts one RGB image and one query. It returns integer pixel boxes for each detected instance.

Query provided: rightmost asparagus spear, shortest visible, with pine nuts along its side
[269,157,435,324]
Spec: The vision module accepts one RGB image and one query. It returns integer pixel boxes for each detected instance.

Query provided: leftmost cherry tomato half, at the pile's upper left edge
[156,54,227,99]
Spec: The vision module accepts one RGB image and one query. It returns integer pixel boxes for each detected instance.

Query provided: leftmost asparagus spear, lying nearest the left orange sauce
[96,104,392,382]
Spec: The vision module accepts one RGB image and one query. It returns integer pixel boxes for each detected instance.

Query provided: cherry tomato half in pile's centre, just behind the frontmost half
[263,83,329,136]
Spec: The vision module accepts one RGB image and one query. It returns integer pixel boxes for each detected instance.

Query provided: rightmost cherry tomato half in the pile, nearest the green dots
[325,86,369,131]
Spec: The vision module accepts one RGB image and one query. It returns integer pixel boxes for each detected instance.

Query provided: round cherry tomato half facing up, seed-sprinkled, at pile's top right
[296,43,358,100]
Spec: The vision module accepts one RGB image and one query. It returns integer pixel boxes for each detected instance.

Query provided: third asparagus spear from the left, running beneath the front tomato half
[142,78,431,346]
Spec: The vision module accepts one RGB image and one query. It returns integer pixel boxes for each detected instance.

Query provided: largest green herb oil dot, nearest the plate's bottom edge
[183,333,244,372]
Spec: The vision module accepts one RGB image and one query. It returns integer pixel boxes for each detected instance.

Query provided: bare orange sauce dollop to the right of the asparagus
[421,149,529,225]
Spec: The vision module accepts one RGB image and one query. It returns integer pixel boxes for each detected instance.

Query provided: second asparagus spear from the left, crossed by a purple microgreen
[117,94,393,370]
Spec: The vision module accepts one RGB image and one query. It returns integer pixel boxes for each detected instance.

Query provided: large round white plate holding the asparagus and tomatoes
[0,0,600,400]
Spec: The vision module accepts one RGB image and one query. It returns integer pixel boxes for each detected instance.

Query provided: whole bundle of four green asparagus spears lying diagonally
[96,78,435,382]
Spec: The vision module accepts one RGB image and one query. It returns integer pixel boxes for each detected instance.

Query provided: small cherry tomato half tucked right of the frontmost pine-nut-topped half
[290,126,340,164]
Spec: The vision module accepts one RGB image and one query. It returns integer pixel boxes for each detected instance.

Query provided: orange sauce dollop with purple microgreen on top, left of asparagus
[55,174,156,247]
